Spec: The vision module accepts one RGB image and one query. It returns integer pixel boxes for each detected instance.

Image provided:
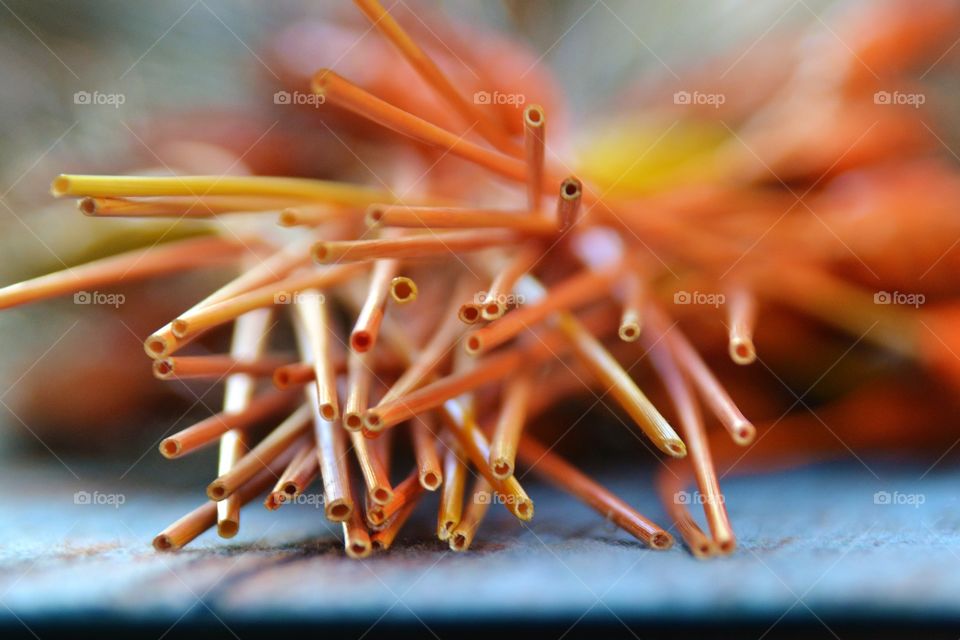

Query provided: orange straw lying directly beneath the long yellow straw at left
[77,196,298,218]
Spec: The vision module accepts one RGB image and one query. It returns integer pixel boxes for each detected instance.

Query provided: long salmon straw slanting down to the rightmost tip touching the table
[644,316,736,553]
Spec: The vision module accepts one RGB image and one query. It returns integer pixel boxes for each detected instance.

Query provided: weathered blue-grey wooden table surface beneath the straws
[0,452,960,638]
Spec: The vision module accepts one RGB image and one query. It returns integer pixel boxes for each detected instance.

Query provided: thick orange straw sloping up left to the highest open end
[313,69,527,184]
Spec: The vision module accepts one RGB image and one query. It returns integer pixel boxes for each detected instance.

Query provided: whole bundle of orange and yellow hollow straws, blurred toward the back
[0,0,960,557]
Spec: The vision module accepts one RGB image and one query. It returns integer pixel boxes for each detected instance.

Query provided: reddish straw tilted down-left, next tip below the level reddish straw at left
[160,391,293,458]
